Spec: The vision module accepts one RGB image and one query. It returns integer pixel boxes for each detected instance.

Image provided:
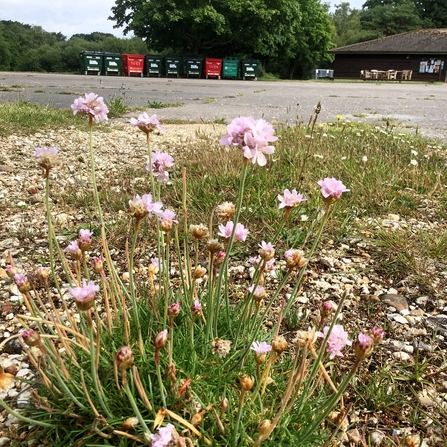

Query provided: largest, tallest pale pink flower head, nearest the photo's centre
[220,116,278,166]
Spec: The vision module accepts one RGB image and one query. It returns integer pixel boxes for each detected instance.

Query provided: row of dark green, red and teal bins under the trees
[80,51,259,80]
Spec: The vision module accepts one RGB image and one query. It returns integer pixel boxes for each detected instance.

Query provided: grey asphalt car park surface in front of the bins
[0,72,447,141]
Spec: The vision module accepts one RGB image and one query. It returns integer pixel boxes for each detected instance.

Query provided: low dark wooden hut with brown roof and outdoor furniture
[331,28,447,82]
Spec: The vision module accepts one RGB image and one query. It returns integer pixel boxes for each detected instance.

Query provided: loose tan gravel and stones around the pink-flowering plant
[0,118,447,447]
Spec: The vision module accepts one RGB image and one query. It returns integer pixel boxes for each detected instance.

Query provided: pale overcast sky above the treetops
[0,0,365,37]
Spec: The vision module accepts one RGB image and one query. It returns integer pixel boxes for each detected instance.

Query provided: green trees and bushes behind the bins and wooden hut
[0,0,447,79]
